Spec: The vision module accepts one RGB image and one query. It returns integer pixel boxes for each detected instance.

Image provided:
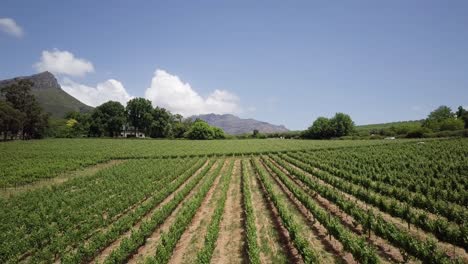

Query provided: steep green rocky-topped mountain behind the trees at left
[0,71,93,118]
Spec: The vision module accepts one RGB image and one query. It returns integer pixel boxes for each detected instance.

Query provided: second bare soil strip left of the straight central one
[127,161,220,263]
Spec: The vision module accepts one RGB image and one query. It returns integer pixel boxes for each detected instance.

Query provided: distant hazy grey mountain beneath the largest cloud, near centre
[190,114,289,135]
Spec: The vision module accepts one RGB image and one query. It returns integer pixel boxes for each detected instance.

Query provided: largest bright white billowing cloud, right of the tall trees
[145,69,241,116]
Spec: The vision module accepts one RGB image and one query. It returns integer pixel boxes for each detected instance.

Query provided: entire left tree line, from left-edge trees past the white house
[0,80,226,140]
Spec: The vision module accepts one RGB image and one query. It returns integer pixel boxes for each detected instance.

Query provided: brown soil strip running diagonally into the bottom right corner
[280,156,468,263]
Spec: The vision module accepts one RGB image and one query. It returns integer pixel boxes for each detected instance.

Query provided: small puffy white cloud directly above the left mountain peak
[34,49,94,76]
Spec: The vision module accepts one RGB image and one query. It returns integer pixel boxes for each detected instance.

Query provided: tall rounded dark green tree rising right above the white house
[126,98,153,132]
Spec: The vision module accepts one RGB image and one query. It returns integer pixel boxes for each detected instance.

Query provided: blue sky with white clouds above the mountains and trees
[0,0,468,129]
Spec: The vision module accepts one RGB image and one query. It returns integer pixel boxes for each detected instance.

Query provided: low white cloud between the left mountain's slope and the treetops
[61,78,133,106]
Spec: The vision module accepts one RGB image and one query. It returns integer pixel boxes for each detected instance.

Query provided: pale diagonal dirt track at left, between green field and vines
[0,160,127,198]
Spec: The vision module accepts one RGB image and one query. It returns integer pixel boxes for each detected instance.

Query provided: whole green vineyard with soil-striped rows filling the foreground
[0,139,468,263]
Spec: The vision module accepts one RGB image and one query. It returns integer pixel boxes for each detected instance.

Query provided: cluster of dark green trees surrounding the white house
[64,98,225,139]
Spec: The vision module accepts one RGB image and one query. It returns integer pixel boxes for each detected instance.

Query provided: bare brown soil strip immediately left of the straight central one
[169,160,229,264]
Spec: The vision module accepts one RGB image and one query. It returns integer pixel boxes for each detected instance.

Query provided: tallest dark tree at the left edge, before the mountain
[1,80,49,139]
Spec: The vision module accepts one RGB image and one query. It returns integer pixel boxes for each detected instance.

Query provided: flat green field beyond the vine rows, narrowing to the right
[0,139,416,187]
